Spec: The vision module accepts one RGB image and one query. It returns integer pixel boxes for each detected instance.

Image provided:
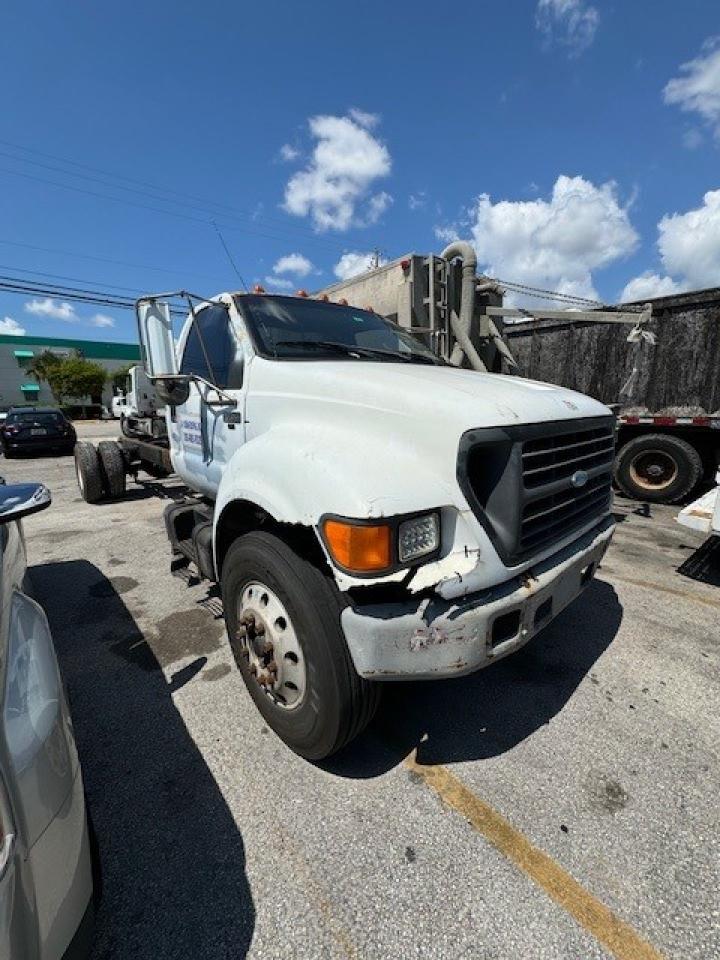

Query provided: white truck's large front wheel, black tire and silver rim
[222,532,380,760]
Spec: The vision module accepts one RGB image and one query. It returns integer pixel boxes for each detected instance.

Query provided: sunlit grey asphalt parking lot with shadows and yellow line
[0,444,720,960]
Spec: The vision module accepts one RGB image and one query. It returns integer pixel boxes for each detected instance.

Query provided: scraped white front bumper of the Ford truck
[342,517,614,680]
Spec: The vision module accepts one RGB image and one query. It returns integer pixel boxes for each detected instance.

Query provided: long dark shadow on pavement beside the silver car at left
[31,560,255,960]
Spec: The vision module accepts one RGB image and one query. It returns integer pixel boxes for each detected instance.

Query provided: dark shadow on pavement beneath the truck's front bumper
[323,580,622,778]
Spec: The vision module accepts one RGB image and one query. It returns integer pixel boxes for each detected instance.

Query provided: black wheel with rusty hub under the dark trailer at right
[615,433,703,503]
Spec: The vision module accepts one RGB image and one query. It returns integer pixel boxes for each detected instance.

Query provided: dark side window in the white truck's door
[180,304,242,389]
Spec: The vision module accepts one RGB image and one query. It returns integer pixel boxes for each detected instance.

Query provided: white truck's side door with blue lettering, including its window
[170,303,245,497]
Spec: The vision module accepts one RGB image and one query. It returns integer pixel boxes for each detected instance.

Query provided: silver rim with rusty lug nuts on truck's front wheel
[235,580,307,711]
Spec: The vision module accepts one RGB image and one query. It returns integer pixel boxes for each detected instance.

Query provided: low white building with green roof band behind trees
[0,334,140,410]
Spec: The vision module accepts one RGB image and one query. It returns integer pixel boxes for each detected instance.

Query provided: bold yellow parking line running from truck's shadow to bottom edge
[405,752,662,960]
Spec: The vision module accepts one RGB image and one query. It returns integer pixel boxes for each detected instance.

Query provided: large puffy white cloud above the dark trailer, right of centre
[448,176,638,299]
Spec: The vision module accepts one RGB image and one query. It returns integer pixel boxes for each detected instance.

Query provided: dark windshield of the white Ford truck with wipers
[238,295,442,364]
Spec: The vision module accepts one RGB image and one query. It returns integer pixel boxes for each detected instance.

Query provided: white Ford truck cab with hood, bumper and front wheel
[78,246,614,759]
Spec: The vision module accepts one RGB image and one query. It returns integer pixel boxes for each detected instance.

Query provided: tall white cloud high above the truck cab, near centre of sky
[283,110,391,231]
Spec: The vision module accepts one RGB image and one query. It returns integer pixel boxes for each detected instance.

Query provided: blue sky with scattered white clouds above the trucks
[0,0,720,340]
